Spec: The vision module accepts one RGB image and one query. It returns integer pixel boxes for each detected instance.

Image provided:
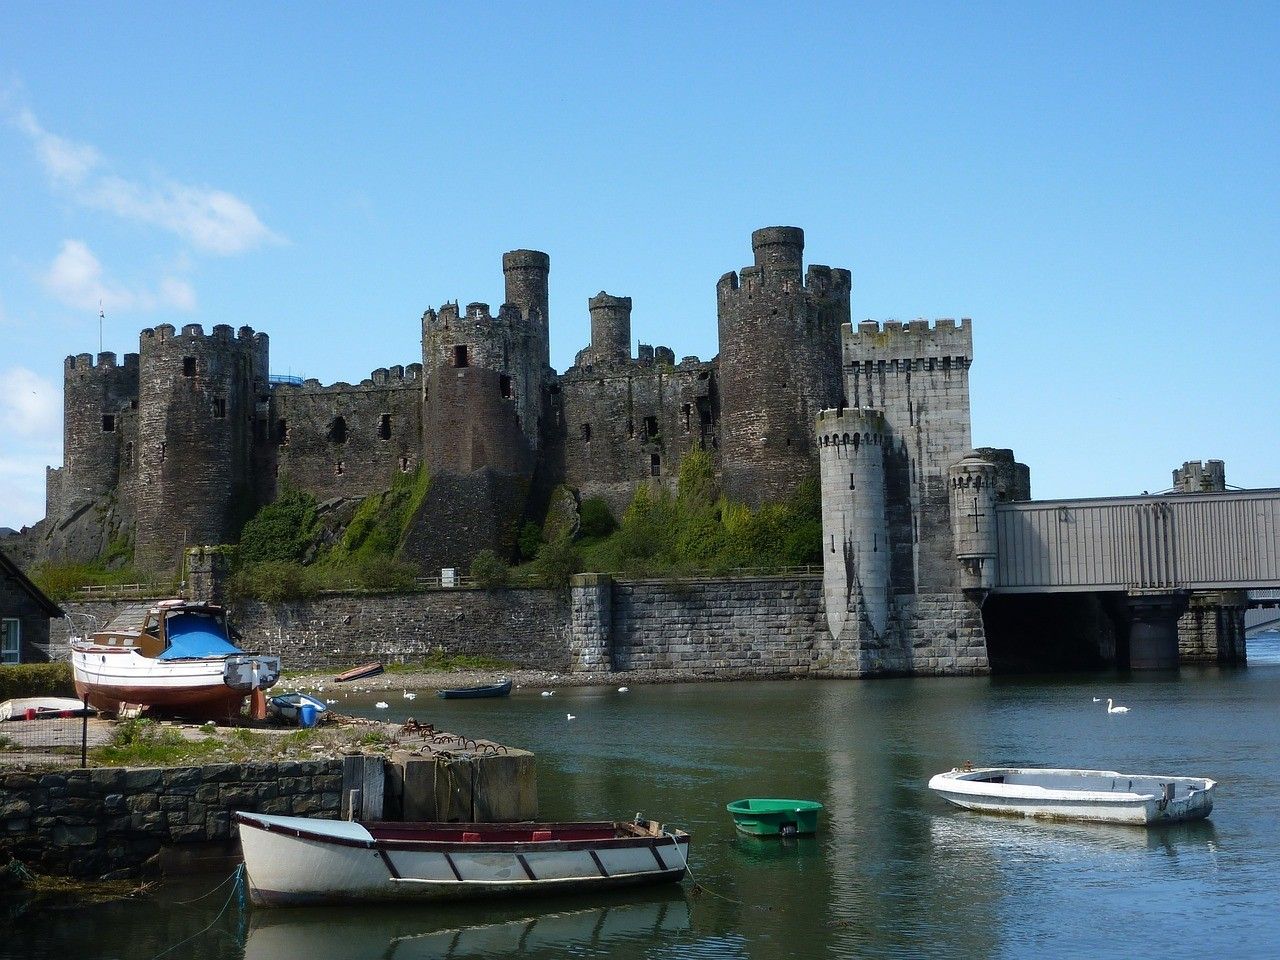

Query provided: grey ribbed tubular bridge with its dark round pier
[974,489,1280,668]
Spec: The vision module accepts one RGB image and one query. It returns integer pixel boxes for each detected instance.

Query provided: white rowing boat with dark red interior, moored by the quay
[233,812,689,906]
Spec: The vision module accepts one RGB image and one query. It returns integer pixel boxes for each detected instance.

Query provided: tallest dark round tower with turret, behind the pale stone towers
[716,227,851,506]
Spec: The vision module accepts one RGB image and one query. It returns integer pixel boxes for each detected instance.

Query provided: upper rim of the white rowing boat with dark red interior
[232,810,689,854]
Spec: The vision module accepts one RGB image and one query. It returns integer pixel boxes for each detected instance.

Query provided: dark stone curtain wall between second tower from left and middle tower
[275,364,422,500]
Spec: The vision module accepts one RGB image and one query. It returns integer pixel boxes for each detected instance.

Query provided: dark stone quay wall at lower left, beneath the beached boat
[0,759,342,878]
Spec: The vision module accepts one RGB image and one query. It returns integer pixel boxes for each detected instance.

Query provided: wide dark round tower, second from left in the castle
[134,324,269,570]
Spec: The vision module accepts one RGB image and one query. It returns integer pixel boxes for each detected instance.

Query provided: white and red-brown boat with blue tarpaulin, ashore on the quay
[70,600,280,719]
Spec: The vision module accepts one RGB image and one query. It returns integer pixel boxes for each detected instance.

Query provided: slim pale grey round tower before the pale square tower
[817,410,892,640]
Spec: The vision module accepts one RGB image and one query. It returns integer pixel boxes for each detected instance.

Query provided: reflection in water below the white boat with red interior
[244,895,689,960]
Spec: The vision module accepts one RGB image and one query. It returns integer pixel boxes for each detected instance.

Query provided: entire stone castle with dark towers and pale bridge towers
[26,227,1259,675]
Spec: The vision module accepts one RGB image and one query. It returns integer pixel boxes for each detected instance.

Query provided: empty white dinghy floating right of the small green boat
[929,767,1217,826]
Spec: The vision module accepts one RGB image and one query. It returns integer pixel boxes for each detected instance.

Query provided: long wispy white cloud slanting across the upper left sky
[17,110,280,256]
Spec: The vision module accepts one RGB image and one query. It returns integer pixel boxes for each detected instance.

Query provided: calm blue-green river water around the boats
[0,635,1280,960]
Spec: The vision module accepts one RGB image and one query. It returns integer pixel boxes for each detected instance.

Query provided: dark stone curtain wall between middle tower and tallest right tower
[559,357,719,516]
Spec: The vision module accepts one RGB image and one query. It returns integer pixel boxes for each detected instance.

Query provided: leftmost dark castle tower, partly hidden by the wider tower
[60,353,138,509]
